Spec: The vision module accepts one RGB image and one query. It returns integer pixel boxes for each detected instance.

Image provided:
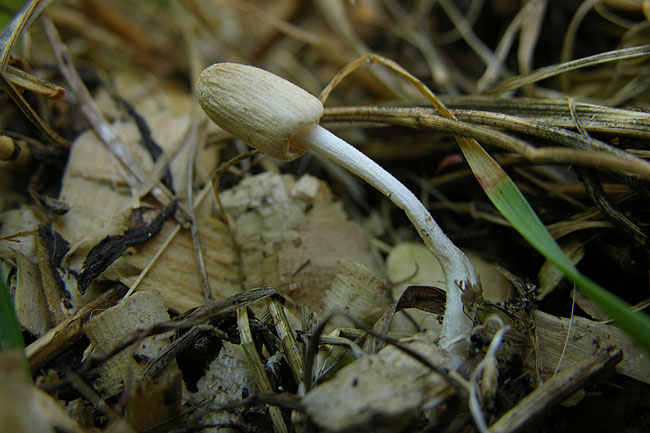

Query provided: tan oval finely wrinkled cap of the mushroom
[196,63,323,161]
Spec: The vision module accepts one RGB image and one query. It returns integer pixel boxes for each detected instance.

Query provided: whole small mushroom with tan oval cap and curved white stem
[197,63,478,361]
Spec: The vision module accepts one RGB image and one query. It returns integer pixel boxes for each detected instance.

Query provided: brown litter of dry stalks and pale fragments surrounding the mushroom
[0,0,650,432]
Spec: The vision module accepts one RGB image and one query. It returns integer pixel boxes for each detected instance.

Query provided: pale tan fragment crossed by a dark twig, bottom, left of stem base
[302,333,452,431]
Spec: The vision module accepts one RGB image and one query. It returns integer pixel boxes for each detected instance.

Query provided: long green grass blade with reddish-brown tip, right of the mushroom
[461,140,650,353]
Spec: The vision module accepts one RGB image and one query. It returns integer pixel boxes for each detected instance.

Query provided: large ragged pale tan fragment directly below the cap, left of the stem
[220,172,379,306]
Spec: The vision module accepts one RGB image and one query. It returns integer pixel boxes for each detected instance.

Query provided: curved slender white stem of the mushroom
[291,125,477,352]
